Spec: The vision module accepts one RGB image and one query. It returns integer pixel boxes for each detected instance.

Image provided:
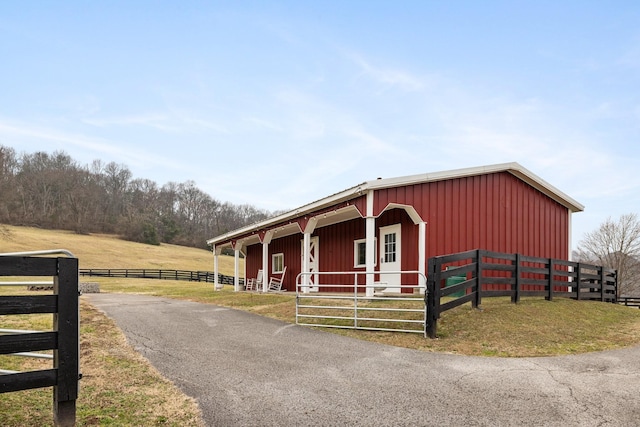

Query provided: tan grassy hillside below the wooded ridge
[0,226,242,275]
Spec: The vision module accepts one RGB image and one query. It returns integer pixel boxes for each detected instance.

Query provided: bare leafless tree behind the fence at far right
[575,213,640,296]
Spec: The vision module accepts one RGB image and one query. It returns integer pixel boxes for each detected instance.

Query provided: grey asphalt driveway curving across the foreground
[83,294,640,427]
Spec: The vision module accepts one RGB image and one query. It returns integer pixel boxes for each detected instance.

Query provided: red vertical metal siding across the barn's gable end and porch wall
[246,172,569,291]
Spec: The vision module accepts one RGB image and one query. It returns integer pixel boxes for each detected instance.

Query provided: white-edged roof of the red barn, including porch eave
[207,162,584,246]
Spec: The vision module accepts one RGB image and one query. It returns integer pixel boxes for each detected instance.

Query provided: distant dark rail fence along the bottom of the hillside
[79,268,239,285]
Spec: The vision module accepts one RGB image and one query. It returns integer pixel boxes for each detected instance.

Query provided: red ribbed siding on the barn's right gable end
[374,172,569,262]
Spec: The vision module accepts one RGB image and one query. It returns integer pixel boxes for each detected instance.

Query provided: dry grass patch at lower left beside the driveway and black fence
[0,301,204,427]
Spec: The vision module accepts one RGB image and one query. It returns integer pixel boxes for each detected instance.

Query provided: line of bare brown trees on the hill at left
[0,145,272,248]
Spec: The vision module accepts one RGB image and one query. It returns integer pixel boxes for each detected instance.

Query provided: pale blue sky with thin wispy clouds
[0,0,640,246]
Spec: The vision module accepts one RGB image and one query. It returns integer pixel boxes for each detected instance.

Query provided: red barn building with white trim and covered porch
[207,163,584,291]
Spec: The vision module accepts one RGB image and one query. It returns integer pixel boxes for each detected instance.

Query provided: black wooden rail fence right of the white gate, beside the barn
[426,250,617,338]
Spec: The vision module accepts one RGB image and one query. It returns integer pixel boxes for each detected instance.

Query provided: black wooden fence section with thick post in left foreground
[0,256,80,426]
